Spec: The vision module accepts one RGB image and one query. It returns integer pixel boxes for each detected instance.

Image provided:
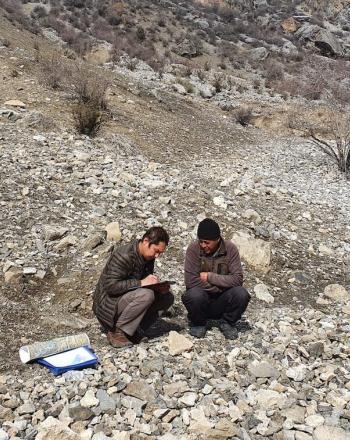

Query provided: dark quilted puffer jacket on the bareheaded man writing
[92,240,154,330]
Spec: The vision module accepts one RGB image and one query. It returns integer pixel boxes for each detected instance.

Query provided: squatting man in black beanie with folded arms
[182,218,250,339]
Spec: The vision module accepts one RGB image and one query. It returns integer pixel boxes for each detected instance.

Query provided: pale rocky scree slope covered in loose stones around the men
[0,18,350,440]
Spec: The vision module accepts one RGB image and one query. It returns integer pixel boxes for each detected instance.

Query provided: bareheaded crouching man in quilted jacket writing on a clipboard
[93,226,174,347]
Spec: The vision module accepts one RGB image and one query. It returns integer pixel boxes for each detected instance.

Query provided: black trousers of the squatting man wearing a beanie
[182,286,250,325]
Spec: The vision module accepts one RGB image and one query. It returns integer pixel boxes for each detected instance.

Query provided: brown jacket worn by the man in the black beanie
[185,240,243,293]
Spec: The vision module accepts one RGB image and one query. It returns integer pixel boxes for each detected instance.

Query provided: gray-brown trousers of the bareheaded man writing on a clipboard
[115,287,174,336]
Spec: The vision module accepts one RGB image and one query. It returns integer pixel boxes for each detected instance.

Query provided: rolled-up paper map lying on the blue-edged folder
[19,333,90,364]
